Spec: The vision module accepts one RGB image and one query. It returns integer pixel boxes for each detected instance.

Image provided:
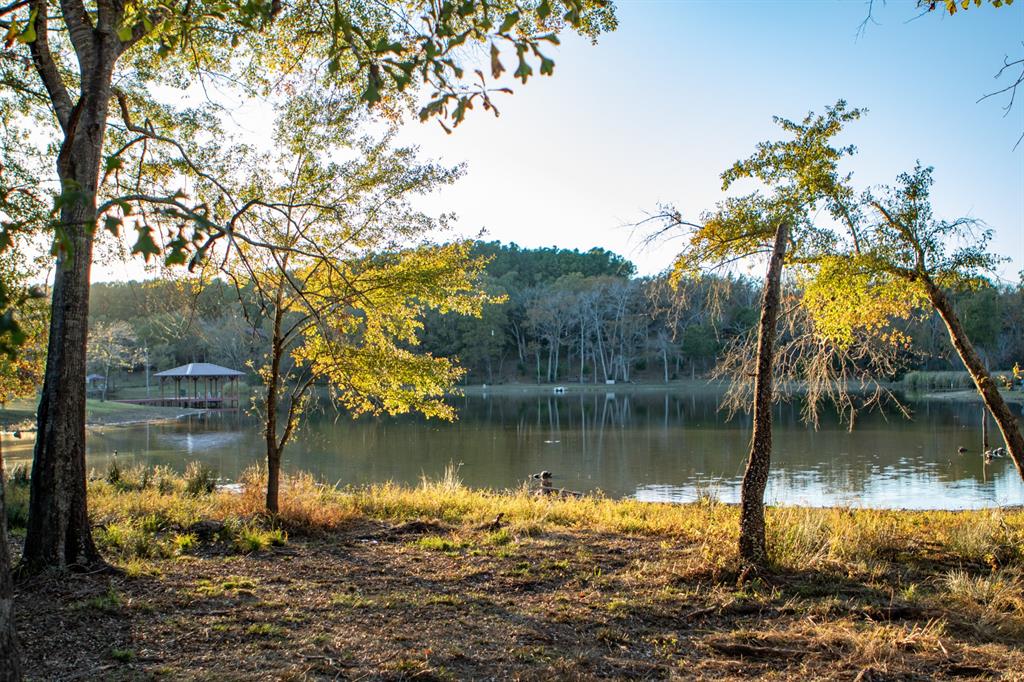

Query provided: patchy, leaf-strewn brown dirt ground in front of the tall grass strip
[15,521,1024,682]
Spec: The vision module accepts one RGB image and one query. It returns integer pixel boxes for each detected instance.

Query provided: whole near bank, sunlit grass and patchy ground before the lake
[9,468,1024,680]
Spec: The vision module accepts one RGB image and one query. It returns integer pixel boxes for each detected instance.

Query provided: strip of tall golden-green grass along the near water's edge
[7,465,1024,570]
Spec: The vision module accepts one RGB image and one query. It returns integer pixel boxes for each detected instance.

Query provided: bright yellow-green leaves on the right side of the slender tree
[289,238,502,419]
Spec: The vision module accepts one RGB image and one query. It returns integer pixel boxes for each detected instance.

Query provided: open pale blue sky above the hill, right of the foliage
[391,0,1024,281]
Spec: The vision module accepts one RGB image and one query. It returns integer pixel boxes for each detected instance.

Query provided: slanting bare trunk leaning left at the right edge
[924,278,1024,478]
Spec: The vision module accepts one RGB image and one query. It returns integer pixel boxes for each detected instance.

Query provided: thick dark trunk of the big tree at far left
[20,41,119,572]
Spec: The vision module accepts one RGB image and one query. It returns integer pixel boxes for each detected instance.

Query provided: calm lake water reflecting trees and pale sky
[4,390,1024,509]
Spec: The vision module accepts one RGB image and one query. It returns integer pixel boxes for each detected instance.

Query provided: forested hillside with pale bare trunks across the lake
[90,242,1024,384]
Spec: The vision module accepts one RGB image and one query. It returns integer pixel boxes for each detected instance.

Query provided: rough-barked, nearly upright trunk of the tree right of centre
[739,222,790,566]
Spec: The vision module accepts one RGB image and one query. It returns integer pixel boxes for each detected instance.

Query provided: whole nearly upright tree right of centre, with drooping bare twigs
[652,100,900,567]
